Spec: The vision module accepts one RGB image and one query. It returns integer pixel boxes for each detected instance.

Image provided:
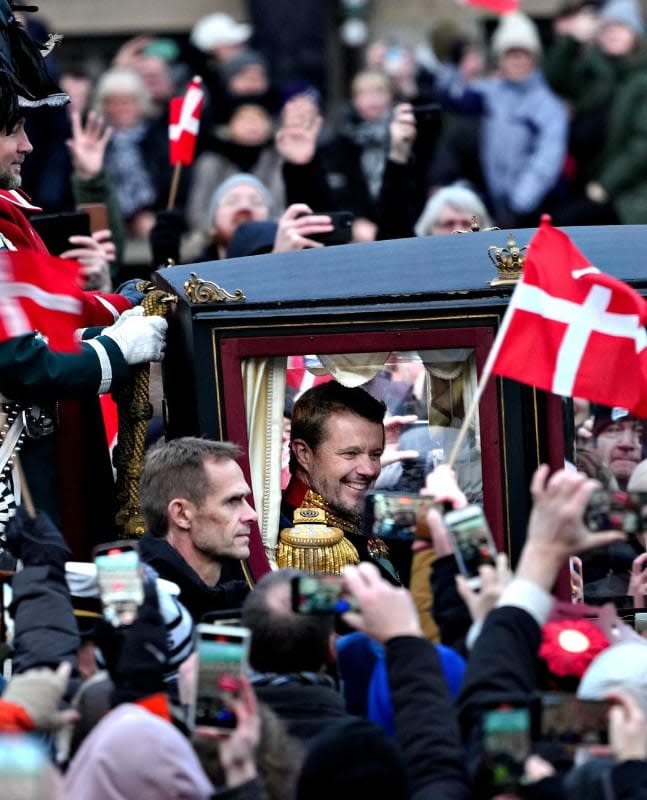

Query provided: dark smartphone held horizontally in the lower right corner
[539,692,610,754]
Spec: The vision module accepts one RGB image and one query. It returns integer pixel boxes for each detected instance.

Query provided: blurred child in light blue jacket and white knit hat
[437,12,568,227]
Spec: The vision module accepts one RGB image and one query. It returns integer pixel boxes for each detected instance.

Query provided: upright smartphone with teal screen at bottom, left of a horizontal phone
[481,705,531,794]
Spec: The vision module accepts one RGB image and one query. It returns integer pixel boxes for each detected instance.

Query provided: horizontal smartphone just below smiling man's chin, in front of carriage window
[364,491,434,542]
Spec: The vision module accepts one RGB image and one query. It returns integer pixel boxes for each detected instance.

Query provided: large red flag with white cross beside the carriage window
[488,217,647,416]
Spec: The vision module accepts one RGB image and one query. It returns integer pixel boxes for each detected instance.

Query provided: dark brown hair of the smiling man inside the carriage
[290,381,386,475]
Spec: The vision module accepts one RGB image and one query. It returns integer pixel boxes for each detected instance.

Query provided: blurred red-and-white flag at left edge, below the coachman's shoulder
[0,250,83,353]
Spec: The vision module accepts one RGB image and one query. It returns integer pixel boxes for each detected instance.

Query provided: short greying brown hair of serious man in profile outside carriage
[139,436,240,537]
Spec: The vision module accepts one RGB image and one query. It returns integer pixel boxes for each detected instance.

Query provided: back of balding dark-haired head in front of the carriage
[240,569,334,674]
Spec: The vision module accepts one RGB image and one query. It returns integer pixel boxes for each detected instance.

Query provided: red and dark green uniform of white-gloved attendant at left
[0,190,132,557]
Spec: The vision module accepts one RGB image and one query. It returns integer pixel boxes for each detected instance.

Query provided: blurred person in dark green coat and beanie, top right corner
[547,0,647,225]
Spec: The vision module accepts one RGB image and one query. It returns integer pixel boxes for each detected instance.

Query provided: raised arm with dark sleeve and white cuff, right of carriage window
[458,464,624,796]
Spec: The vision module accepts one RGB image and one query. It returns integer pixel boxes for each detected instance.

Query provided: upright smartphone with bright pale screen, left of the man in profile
[92,541,144,627]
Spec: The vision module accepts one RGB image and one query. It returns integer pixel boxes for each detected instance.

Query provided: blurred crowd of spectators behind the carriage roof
[16,0,647,281]
